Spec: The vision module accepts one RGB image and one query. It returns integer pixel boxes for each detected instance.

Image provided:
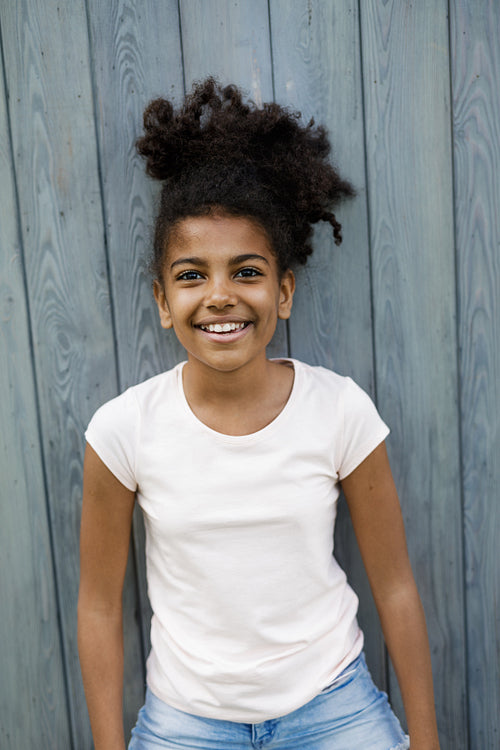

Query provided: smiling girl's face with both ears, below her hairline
[154,215,295,372]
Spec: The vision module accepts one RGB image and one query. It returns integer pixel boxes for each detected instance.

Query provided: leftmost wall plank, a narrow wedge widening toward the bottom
[0,45,71,750]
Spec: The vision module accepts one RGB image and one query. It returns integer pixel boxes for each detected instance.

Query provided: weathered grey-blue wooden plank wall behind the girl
[0,0,500,750]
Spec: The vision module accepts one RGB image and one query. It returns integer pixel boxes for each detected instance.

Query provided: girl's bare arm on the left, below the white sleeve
[78,444,135,750]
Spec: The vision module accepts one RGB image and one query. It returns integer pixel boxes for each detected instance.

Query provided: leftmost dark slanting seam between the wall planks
[0,11,76,750]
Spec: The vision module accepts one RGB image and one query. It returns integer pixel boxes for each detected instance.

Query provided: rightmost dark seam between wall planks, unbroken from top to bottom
[447,0,471,747]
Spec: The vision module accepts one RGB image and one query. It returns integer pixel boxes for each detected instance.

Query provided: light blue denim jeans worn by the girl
[129,655,410,750]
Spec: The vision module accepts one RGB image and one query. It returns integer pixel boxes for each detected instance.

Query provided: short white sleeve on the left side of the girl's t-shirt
[85,388,139,491]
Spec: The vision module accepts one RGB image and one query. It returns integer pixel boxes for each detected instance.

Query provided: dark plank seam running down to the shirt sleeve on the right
[358,0,391,700]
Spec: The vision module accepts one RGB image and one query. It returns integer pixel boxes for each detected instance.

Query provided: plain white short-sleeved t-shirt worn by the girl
[86,360,389,723]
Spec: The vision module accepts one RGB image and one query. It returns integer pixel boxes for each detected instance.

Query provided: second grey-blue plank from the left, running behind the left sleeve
[0,0,144,748]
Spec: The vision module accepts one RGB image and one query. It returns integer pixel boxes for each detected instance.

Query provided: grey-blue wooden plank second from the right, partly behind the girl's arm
[361,0,467,750]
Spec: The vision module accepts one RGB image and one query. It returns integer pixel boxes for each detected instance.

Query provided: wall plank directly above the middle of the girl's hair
[180,0,288,357]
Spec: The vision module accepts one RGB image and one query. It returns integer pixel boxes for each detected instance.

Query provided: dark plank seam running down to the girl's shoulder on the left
[81,0,146,682]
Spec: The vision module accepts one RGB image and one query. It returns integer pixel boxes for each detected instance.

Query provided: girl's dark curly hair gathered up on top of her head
[137,77,354,278]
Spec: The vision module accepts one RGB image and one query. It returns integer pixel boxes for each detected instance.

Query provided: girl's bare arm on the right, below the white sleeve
[342,443,439,750]
